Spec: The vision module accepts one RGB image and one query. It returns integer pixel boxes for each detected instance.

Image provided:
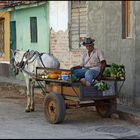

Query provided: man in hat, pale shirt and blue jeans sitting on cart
[71,37,106,87]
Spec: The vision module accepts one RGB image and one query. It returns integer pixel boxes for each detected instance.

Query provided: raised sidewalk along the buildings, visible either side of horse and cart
[0,76,140,125]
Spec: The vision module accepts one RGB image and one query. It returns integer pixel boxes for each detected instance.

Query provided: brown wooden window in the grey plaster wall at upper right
[122,0,132,39]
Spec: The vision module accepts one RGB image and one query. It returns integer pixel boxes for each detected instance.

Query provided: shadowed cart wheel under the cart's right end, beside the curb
[95,99,117,118]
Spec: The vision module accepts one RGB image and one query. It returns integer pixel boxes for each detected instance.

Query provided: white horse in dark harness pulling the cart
[12,50,60,112]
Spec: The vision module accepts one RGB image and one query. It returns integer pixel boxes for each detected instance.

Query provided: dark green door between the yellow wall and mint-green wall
[10,21,16,62]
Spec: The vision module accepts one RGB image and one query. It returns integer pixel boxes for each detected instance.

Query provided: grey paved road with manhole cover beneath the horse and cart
[0,96,140,139]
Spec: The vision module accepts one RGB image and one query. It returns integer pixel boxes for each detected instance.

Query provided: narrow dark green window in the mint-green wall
[30,17,37,43]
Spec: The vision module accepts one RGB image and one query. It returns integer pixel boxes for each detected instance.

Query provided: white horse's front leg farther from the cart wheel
[25,78,31,112]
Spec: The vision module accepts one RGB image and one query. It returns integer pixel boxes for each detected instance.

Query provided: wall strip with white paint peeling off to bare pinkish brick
[50,1,81,69]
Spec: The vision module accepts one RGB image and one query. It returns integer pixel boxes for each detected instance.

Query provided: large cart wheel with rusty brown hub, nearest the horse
[44,93,66,124]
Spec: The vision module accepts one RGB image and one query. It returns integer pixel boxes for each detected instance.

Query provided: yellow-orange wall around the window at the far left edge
[0,12,10,61]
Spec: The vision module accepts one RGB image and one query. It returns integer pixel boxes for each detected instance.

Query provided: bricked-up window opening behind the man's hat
[70,1,87,49]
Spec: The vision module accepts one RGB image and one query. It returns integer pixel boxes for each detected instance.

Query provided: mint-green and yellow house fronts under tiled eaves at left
[0,1,49,79]
